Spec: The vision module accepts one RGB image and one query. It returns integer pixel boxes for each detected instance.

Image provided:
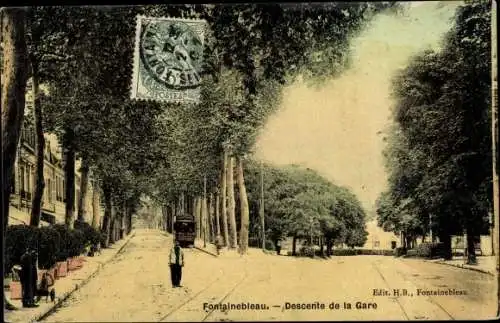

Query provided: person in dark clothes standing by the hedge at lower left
[20,249,38,307]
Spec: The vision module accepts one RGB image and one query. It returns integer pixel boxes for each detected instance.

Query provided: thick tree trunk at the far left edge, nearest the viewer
[0,8,28,309]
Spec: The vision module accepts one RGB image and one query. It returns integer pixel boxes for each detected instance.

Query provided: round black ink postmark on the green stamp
[140,21,203,90]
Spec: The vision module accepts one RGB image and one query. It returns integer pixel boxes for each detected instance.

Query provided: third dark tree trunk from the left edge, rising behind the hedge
[64,129,75,229]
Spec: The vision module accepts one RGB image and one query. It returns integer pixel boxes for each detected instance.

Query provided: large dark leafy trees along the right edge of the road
[377,1,493,263]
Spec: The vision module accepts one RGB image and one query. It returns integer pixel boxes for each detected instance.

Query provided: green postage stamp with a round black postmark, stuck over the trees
[131,16,205,103]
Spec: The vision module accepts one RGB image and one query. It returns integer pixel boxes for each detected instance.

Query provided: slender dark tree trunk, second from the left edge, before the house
[30,63,45,227]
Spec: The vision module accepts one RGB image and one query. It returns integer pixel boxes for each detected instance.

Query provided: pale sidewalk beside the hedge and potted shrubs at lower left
[4,231,135,323]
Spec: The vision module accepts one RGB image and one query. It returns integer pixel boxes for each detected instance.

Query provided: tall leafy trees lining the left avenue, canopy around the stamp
[1,2,397,284]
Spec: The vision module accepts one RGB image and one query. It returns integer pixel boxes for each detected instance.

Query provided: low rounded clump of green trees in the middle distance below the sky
[242,161,367,255]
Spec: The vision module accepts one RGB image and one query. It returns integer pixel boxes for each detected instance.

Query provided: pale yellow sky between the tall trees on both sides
[256,1,460,213]
